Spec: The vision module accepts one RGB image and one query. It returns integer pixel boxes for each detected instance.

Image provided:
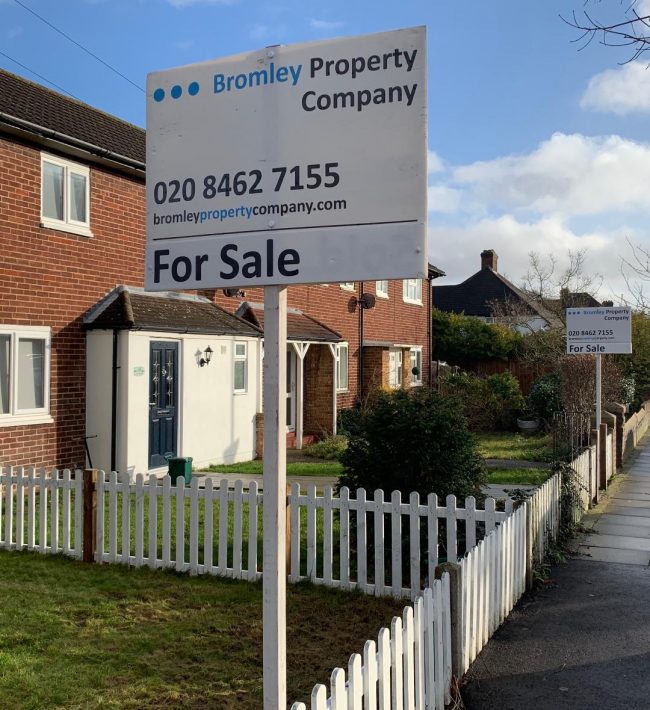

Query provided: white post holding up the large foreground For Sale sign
[262,286,287,710]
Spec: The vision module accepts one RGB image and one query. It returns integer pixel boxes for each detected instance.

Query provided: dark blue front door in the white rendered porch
[149,341,178,468]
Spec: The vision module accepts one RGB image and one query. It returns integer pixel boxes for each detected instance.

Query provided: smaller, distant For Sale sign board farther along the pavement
[566,307,632,355]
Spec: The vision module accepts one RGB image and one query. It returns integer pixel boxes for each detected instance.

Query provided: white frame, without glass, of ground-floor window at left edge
[0,324,54,427]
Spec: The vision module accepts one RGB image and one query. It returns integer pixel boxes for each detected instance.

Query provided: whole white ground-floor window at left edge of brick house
[0,325,52,426]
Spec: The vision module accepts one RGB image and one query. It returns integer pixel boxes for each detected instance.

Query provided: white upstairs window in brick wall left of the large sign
[41,153,92,237]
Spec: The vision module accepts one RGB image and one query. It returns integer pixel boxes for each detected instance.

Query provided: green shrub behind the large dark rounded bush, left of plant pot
[443,372,526,431]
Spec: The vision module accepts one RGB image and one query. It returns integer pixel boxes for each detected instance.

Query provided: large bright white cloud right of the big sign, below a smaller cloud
[450,133,650,218]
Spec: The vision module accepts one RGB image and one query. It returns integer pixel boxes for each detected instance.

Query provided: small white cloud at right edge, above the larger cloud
[580,62,650,116]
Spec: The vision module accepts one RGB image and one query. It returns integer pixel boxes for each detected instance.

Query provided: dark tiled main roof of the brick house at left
[0,69,145,170]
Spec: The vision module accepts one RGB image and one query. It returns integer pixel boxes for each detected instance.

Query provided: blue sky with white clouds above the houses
[0,0,650,303]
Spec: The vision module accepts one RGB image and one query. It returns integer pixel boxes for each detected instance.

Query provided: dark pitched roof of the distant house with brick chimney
[431,268,560,326]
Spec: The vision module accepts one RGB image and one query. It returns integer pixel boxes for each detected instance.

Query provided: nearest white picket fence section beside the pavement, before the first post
[291,573,451,710]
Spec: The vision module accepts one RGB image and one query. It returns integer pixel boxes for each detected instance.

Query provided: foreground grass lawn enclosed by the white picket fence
[0,551,405,710]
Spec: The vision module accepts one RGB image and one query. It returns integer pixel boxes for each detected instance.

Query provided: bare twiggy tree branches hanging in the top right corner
[560,0,650,64]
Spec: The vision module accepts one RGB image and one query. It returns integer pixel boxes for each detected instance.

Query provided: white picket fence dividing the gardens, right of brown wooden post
[91,472,512,598]
